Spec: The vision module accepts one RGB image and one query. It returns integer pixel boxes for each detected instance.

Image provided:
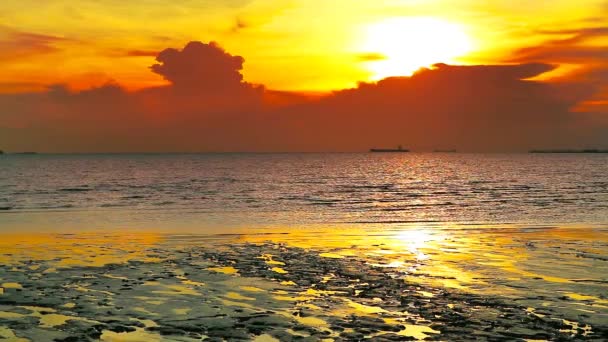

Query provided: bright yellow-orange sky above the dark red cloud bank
[0,0,608,91]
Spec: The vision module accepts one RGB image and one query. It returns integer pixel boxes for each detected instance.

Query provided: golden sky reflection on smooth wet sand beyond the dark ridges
[0,225,608,328]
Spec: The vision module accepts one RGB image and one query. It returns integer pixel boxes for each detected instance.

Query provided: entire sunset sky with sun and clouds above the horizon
[0,0,608,152]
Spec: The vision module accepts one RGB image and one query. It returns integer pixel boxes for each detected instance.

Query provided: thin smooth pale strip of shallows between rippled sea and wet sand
[0,208,608,235]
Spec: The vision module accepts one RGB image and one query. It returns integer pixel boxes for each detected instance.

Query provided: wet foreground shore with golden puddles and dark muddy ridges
[0,226,608,341]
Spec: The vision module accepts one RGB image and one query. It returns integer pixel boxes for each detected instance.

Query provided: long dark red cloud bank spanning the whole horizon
[0,42,608,152]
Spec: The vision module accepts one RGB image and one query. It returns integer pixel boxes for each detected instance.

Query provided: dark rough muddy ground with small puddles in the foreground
[0,238,608,342]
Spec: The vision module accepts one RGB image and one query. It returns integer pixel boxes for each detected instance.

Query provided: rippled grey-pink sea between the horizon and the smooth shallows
[0,153,608,225]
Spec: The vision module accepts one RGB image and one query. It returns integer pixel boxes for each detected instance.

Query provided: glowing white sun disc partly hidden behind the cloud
[362,17,473,80]
